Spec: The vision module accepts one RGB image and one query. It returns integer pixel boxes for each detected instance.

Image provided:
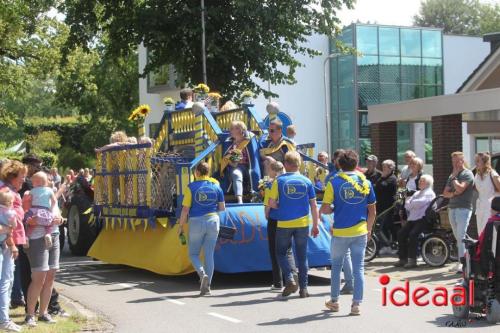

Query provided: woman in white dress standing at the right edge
[474,153,500,235]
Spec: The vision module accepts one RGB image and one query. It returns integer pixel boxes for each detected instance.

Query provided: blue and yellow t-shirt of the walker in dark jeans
[269,173,316,228]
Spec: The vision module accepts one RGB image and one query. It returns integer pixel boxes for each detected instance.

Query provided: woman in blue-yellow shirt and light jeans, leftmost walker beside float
[179,162,226,296]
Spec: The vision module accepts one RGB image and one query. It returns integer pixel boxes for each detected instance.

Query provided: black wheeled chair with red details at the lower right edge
[453,220,500,324]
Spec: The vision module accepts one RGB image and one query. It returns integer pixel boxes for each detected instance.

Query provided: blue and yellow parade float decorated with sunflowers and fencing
[74,86,330,275]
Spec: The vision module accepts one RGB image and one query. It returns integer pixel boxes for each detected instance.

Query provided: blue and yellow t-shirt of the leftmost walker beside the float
[182,177,224,217]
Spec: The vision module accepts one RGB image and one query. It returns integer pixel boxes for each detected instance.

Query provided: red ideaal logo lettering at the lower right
[379,274,474,306]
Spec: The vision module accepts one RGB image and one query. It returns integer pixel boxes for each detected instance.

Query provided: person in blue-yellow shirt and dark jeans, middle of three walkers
[269,151,319,298]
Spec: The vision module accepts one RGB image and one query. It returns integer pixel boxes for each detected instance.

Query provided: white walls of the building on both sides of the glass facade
[139,28,490,163]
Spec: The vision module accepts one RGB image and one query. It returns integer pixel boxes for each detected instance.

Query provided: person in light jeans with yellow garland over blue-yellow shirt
[321,150,376,315]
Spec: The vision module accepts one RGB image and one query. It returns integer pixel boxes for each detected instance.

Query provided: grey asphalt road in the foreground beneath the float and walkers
[57,248,500,333]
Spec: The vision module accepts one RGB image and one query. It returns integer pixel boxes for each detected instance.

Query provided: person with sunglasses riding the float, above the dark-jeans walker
[260,120,296,175]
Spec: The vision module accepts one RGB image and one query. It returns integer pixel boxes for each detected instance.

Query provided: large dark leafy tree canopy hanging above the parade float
[60,0,354,97]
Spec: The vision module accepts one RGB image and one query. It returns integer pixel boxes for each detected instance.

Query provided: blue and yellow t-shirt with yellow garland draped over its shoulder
[323,172,376,237]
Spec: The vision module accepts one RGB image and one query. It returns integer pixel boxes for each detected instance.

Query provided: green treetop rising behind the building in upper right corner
[413,0,500,36]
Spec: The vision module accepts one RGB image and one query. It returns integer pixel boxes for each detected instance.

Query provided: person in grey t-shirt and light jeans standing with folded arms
[443,152,474,273]
